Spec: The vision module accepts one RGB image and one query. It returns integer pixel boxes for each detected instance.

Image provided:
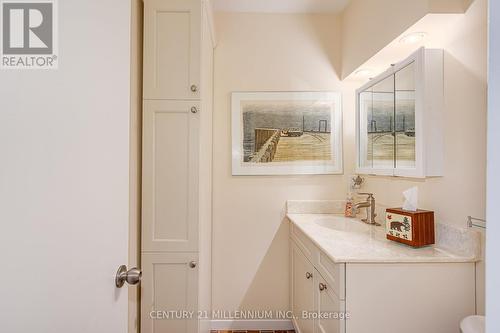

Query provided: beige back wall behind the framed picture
[213,13,354,310]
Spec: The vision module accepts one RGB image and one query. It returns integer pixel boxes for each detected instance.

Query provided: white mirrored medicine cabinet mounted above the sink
[356,48,444,178]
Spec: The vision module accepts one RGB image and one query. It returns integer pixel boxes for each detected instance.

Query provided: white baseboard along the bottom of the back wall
[210,319,294,331]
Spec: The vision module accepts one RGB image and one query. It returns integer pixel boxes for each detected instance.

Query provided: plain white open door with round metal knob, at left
[0,0,130,333]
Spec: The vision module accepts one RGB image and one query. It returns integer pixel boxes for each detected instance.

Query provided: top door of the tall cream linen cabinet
[144,0,201,99]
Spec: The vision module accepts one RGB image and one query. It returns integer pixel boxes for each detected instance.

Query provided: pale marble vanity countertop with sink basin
[287,212,479,263]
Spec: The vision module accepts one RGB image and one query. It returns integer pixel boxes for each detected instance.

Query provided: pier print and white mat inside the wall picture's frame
[233,93,341,173]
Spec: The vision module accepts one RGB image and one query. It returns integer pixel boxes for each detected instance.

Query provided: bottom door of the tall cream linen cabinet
[141,253,198,333]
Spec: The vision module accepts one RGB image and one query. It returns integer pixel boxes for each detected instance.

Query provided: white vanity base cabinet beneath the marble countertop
[290,223,475,333]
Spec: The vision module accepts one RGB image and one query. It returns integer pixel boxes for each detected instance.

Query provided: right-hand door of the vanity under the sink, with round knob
[314,271,345,333]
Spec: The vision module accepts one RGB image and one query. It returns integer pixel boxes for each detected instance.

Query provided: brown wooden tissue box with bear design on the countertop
[385,208,434,247]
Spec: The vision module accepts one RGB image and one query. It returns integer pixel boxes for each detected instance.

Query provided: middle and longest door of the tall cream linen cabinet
[142,101,199,252]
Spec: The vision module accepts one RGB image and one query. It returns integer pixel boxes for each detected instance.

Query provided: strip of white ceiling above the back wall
[213,0,350,13]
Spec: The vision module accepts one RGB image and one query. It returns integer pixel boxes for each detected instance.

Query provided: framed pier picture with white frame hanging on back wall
[231,92,343,175]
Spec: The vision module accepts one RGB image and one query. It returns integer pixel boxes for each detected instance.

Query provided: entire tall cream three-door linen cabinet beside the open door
[141,0,215,333]
